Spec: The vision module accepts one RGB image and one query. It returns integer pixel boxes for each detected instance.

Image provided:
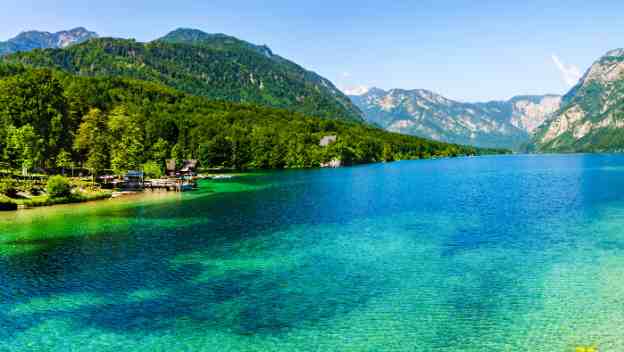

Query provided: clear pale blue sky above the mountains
[0,0,624,101]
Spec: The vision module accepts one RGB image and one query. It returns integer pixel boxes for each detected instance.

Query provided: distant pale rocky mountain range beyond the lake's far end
[351,88,561,150]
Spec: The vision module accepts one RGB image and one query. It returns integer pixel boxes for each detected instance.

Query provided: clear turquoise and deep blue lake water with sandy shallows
[0,155,624,352]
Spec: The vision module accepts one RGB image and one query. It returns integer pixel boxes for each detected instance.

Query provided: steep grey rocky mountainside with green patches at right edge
[533,49,624,152]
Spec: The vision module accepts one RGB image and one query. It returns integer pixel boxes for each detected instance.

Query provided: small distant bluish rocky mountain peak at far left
[0,27,98,56]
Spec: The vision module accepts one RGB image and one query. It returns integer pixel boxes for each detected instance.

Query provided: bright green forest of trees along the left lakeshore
[0,64,499,173]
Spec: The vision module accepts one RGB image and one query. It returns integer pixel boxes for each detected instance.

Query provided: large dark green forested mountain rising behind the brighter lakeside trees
[5,29,362,121]
